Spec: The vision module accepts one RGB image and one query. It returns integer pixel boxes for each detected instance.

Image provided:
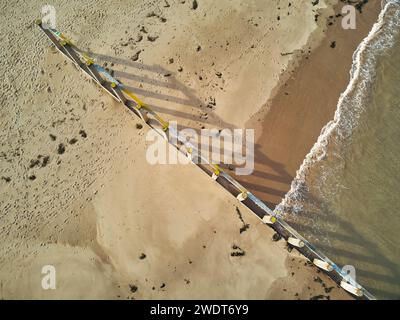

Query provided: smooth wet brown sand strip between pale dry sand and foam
[236,2,381,209]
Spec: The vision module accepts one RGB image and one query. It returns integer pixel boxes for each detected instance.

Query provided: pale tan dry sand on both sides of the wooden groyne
[0,0,349,299]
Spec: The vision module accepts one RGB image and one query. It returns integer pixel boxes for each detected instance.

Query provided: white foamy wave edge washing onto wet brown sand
[275,0,400,216]
